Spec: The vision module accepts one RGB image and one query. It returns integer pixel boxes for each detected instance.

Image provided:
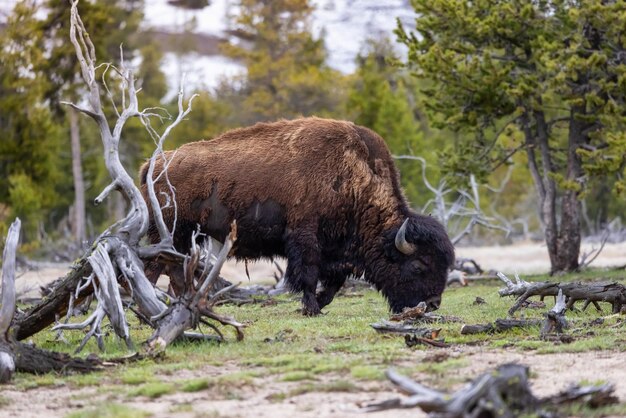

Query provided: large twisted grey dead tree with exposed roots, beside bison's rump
[16,0,242,352]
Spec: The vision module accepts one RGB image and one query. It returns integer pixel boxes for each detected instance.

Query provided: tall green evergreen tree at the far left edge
[0,2,63,241]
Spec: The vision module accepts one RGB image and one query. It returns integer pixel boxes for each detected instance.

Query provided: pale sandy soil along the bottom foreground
[0,347,626,418]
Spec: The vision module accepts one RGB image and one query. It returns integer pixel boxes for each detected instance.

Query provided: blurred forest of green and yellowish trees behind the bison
[0,0,626,272]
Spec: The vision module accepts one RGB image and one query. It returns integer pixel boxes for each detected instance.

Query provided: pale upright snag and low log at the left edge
[0,219,102,383]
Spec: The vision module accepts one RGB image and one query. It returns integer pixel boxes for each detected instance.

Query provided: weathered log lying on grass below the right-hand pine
[498,273,626,315]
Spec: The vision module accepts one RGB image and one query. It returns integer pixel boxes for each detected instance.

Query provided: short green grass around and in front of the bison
[9,270,626,416]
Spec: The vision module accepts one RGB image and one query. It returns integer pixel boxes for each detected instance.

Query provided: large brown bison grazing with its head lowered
[141,118,454,315]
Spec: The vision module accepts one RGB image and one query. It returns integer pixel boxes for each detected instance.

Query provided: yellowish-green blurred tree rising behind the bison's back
[218,0,342,124]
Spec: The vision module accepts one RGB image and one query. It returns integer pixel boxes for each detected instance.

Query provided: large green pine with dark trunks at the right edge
[397,0,626,272]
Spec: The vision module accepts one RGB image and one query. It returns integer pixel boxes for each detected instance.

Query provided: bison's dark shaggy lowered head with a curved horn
[380,214,454,313]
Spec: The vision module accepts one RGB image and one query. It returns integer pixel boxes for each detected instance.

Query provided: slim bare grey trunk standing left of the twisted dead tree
[68,109,87,247]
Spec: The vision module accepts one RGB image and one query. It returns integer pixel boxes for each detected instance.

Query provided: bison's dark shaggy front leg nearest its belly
[285,229,321,316]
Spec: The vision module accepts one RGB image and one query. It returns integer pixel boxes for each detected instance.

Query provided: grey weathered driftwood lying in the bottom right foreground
[365,363,617,418]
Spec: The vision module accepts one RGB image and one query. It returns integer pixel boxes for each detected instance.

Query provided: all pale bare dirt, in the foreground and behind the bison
[7,243,626,418]
